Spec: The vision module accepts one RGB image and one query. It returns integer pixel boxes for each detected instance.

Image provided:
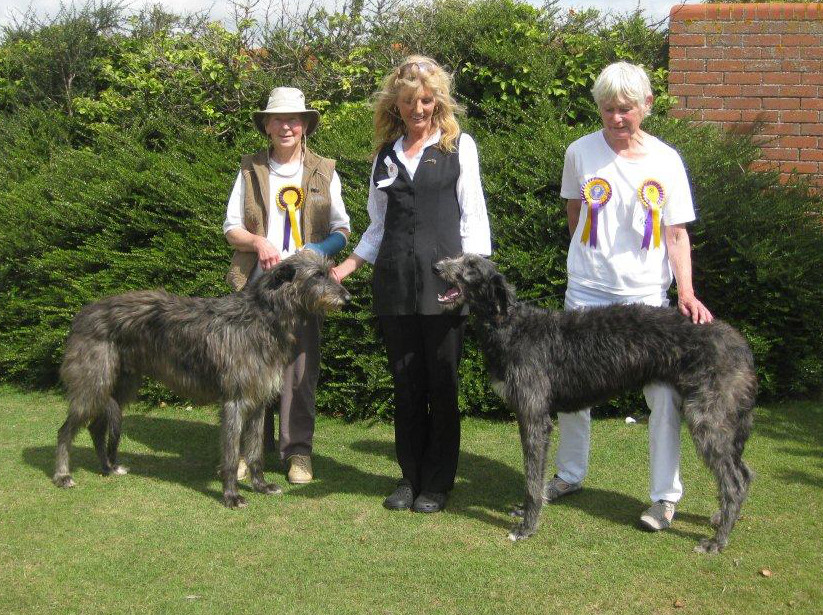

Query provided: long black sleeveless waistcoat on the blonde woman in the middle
[372,137,463,316]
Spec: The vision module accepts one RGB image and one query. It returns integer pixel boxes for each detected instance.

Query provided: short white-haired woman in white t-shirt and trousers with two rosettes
[544,62,712,531]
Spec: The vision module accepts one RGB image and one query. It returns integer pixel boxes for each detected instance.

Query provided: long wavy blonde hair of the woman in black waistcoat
[374,55,463,155]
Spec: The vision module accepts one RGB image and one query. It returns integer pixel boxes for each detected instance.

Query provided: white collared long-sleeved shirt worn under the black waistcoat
[354,130,492,263]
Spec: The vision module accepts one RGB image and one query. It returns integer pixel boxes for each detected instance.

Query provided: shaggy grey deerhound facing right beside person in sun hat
[52,250,349,508]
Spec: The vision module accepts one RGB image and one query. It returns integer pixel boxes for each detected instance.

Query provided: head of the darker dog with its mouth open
[433,254,517,316]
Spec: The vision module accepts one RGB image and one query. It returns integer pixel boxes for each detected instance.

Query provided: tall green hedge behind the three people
[0,0,823,419]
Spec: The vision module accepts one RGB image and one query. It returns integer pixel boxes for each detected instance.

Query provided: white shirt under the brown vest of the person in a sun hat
[223,159,350,277]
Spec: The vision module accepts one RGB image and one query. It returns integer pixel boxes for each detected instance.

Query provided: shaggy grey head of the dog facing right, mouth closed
[255,250,351,314]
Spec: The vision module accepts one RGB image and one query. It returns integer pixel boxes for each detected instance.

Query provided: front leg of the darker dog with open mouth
[509,409,552,541]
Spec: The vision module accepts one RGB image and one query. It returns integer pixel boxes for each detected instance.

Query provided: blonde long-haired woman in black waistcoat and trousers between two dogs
[332,56,491,513]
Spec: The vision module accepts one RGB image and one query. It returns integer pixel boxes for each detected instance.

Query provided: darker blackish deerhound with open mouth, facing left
[435,255,756,552]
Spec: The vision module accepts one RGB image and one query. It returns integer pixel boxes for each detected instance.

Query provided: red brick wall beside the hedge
[669,4,823,185]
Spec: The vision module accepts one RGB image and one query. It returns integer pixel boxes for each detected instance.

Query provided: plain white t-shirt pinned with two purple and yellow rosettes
[560,131,695,297]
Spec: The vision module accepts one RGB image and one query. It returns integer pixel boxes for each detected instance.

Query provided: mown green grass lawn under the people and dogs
[0,387,823,615]
